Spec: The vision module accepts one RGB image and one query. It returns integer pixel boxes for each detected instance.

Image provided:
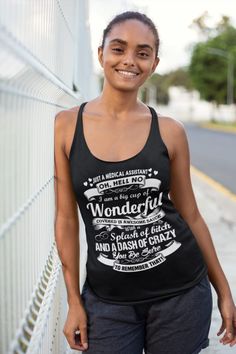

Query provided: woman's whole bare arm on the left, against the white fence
[54,111,88,350]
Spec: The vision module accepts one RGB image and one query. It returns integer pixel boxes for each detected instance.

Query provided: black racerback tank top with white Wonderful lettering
[69,102,207,304]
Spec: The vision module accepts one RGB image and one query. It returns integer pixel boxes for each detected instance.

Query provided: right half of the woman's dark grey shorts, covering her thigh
[145,277,212,354]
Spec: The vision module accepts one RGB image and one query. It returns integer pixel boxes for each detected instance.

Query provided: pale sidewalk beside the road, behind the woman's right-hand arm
[191,170,236,354]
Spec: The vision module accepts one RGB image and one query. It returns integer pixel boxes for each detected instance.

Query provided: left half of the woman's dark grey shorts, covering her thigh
[82,283,145,354]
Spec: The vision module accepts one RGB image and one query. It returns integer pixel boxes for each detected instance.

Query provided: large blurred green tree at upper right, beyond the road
[189,16,236,104]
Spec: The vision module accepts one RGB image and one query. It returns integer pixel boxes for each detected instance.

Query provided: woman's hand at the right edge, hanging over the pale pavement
[217,297,236,347]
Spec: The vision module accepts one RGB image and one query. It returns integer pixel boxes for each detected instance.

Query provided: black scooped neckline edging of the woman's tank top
[78,102,155,164]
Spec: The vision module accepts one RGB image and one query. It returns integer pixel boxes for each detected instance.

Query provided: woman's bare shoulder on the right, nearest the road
[158,114,187,159]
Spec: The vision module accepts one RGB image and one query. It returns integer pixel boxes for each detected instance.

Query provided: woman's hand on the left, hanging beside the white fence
[63,304,88,351]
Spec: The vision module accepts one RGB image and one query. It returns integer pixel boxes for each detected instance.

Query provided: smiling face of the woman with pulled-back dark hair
[98,20,159,91]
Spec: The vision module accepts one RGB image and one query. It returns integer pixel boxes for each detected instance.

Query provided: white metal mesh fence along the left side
[0,0,97,354]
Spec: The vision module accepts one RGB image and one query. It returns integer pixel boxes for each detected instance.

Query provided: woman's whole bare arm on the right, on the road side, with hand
[166,121,236,346]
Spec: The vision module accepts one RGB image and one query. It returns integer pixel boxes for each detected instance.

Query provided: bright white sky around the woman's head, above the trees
[89,0,236,74]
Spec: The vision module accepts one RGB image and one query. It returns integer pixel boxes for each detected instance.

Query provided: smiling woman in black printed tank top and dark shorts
[55,12,236,354]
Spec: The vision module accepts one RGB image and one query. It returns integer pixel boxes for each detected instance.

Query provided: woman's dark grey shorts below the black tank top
[82,276,212,354]
